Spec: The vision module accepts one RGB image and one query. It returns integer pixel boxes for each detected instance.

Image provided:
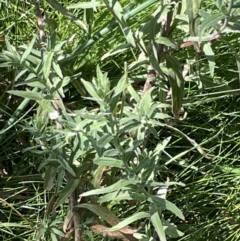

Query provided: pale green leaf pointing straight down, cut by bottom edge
[150,204,167,241]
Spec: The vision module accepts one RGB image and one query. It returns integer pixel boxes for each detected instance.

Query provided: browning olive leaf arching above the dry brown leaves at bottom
[75,203,120,226]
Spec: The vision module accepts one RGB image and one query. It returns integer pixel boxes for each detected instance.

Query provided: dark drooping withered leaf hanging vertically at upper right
[165,55,184,119]
